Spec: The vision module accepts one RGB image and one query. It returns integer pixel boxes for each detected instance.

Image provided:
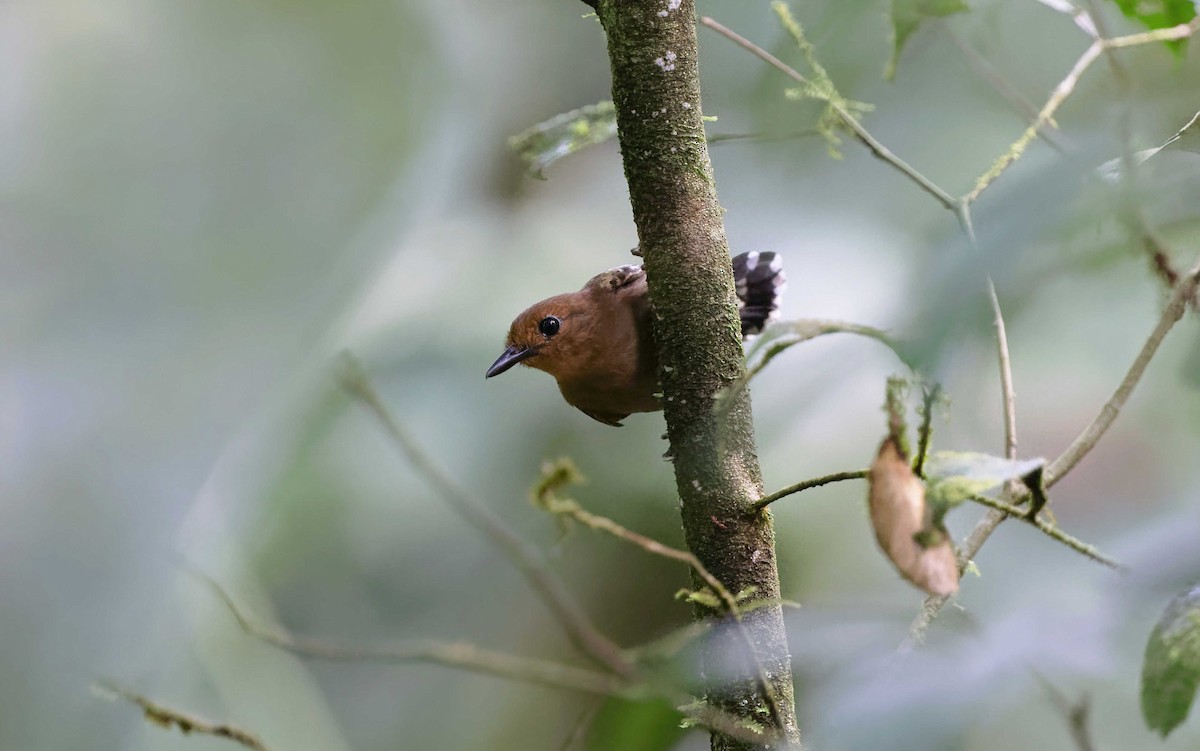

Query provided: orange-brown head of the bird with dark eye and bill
[486,293,584,378]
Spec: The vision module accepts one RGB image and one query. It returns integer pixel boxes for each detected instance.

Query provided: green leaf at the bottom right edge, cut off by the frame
[1141,587,1200,738]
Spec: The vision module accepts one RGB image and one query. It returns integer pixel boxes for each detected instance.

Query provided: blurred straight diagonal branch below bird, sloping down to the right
[341,353,636,679]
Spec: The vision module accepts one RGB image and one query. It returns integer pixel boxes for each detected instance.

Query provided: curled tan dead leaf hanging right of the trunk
[868,435,959,595]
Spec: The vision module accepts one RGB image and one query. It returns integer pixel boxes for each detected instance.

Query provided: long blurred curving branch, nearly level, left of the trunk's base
[187,567,629,696]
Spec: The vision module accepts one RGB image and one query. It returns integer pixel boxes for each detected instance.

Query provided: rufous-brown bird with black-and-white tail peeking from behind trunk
[485,251,786,427]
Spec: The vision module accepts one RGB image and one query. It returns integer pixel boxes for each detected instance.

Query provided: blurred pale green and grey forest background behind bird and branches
[0,0,1200,751]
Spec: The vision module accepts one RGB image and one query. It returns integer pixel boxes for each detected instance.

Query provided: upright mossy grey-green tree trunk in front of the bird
[596,0,799,749]
